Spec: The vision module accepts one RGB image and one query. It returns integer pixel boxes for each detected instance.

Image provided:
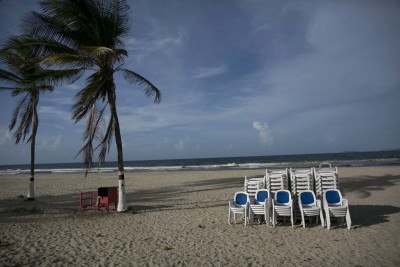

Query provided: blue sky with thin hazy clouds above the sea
[0,0,400,165]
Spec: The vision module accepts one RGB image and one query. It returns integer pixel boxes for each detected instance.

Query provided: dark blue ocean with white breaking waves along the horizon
[0,150,400,175]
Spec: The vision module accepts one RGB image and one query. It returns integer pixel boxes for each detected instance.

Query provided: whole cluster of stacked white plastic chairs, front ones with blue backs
[228,162,351,229]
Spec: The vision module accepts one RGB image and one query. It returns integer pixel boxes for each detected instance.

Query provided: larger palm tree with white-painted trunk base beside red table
[14,0,161,211]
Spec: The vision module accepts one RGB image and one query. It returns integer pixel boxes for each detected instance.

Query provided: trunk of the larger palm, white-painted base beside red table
[108,89,127,212]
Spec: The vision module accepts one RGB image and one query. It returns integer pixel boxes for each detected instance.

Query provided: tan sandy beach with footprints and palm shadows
[0,167,400,266]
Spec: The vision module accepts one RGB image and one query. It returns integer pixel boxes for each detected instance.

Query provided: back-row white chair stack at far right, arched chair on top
[314,162,339,197]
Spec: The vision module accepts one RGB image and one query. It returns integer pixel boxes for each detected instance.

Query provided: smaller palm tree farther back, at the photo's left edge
[0,43,79,200]
